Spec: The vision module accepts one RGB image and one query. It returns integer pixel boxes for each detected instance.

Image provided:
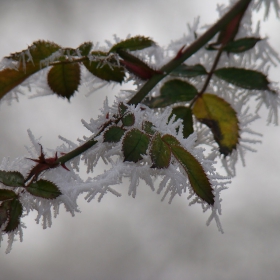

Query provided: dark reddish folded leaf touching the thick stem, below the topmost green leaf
[118,50,158,80]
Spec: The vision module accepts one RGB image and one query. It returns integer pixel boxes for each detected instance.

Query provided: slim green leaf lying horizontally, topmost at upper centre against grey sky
[109,36,155,52]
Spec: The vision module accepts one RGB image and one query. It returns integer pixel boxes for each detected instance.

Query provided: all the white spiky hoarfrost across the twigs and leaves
[0,0,280,251]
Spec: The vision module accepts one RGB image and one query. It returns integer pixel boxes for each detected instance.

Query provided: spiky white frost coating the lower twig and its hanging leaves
[0,101,229,251]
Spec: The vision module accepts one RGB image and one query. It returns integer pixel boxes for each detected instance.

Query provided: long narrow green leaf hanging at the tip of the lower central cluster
[171,145,214,205]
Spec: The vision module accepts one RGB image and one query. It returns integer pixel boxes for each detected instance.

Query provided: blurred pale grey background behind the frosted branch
[0,0,280,280]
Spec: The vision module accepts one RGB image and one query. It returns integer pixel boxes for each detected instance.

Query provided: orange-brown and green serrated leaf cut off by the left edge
[0,41,61,99]
